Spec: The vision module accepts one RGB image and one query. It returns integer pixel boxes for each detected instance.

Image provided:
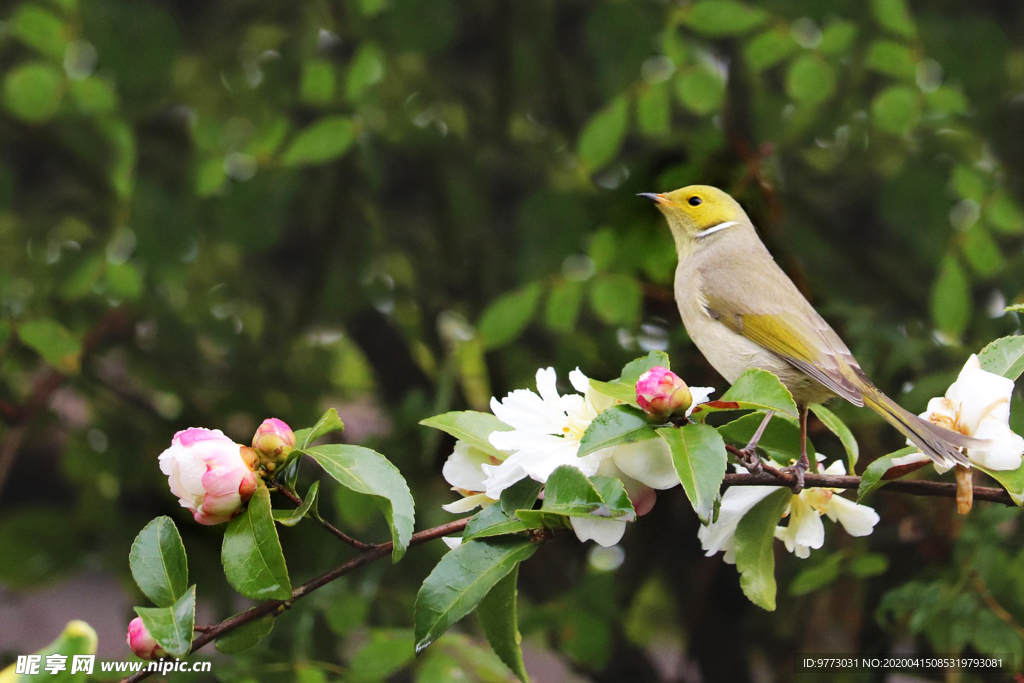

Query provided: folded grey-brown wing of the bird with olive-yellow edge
[700,246,864,405]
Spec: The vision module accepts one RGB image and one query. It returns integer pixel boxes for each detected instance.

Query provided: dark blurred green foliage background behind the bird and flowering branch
[0,0,1024,682]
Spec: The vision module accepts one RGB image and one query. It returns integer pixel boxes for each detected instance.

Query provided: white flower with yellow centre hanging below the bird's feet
[697,456,879,564]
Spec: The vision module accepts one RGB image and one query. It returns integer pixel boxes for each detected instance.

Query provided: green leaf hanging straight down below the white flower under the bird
[736,488,793,611]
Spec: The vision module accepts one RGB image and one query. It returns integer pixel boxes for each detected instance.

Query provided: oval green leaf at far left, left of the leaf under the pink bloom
[128,517,188,607]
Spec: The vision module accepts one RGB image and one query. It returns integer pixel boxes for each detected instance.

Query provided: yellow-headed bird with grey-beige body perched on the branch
[640,185,980,490]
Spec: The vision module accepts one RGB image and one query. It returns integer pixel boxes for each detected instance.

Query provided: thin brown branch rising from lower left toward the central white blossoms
[121,517,470,683]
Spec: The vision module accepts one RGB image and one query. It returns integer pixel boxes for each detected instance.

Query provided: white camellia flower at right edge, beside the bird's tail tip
[892,354,1024,472]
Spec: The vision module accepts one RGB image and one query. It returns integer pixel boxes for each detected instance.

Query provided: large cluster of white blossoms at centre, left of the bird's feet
[442,368,713,547]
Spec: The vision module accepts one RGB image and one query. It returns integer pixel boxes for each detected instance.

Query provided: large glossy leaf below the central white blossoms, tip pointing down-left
[415,537,537,653]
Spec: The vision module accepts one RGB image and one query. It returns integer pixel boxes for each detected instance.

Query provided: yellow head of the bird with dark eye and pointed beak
[640,185,753,255]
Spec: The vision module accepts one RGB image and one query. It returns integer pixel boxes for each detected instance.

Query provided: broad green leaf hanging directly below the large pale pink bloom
[220,483,292,600]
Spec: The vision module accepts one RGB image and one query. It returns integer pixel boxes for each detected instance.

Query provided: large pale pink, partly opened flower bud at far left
[160,427,256,524]
